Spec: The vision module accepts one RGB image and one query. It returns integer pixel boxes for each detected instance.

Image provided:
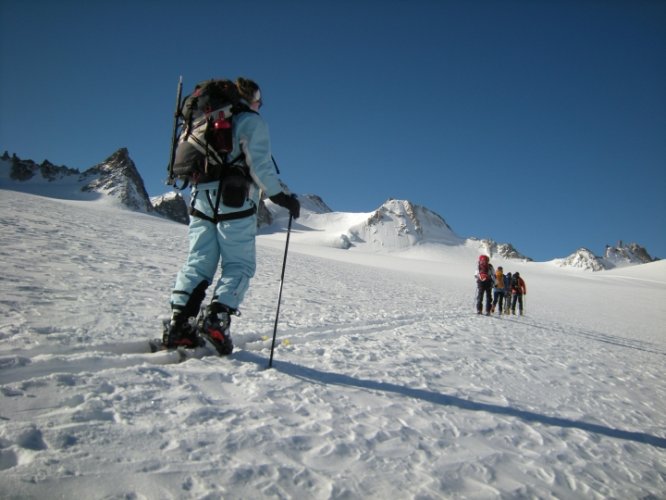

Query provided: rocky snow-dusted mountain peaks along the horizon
[0,148,657,271]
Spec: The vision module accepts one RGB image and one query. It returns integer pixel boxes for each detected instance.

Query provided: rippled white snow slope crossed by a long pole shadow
[0,190,666,499]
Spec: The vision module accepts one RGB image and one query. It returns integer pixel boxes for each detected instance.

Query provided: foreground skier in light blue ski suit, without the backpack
[162,78,300,354]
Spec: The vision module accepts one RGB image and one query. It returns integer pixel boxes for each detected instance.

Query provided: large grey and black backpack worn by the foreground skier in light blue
[172,80,250,195]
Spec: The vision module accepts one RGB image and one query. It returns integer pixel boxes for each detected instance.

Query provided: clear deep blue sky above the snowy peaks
[0,0,666,261]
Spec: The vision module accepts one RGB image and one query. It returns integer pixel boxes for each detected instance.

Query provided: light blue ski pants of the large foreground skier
[171,215,257,316]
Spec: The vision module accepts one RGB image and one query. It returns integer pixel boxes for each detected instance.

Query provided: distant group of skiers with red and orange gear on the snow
[475,255,527,316]
